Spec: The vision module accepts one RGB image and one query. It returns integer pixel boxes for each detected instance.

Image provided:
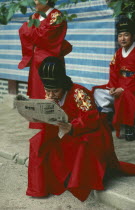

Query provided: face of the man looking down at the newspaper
[45,88,64,101]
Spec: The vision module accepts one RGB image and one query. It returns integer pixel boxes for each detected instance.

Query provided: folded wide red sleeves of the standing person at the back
[18,9,72,69]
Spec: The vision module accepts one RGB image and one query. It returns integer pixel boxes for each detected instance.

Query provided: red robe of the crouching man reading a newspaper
[26,84,135,201]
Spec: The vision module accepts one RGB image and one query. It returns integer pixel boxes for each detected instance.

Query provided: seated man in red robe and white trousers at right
[94,18,135,141]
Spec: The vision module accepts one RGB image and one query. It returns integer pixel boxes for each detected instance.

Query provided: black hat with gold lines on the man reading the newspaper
[39,56,72,90]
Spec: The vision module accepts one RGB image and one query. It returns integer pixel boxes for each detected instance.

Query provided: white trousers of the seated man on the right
[94,88,114,113]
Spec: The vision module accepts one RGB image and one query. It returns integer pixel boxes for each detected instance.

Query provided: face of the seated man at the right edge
[118,32,134,50]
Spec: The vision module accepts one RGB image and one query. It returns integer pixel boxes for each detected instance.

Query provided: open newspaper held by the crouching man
[14,95,68,138]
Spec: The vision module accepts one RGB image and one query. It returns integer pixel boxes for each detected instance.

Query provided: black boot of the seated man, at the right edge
[125,125,135,141]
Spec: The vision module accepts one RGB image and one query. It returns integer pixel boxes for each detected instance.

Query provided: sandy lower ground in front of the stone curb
[0,157,115,210]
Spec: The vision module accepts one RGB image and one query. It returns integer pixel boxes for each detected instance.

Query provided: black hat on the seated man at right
[116,16,135,34]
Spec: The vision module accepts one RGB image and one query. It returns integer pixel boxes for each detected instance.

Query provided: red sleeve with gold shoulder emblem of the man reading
[71,89,100,136]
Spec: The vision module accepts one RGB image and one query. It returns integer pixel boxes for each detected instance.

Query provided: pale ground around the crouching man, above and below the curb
[0,103,135,210]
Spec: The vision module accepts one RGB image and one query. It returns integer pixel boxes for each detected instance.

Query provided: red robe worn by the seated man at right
[94,44,135,131]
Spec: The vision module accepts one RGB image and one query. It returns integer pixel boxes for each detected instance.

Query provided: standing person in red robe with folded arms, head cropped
[18,0,72,128]
